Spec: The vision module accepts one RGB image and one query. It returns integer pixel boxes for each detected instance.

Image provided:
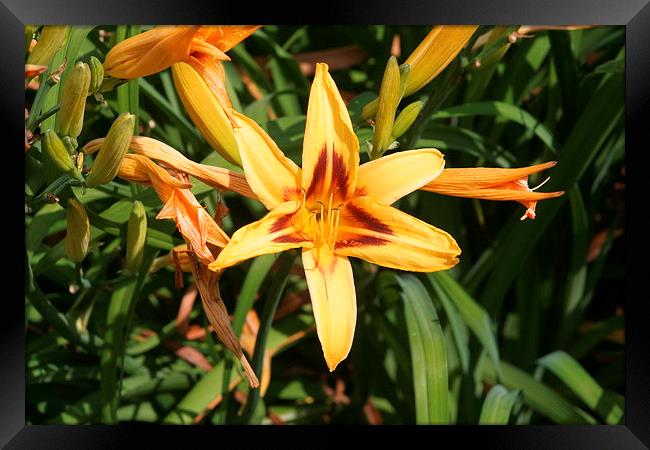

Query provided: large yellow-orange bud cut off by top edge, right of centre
[404,25,478,97]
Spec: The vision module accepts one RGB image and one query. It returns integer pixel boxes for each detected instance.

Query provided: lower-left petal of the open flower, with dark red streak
[210,201,312,271]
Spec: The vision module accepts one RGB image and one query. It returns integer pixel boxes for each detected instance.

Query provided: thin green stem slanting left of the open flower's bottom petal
[243,252,296,424]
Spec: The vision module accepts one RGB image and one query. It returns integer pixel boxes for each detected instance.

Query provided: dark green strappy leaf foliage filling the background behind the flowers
[25,26,625,424]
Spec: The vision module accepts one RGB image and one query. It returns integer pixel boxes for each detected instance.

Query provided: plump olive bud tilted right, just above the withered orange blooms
[86,112,135,187]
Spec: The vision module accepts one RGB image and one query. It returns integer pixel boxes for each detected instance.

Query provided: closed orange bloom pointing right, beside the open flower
[422,161,564,220]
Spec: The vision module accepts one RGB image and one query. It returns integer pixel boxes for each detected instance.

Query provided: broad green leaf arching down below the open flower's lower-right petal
[397,275,449,424]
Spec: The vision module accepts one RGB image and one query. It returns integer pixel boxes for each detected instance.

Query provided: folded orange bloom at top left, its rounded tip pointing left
[104,26,200,79]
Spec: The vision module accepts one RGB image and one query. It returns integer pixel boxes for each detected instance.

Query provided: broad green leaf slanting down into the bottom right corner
[538,350,625,425]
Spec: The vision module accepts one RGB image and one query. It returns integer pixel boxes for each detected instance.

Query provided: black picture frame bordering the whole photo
[10,0,650,449]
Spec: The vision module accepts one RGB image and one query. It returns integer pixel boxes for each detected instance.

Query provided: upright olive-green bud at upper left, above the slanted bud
[57,62,90,138]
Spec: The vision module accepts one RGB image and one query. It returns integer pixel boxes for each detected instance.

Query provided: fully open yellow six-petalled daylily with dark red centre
[209,63,460,371]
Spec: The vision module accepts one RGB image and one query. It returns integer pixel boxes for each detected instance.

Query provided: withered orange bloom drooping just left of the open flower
[117,154,228,264]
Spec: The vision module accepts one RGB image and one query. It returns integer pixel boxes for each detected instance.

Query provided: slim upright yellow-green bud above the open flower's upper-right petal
[372,56,402,158]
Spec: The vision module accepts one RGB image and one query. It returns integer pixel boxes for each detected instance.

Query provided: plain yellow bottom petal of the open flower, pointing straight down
[302,248,357,372]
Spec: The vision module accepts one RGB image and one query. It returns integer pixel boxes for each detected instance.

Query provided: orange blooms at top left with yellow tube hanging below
[104,25,261,165]
